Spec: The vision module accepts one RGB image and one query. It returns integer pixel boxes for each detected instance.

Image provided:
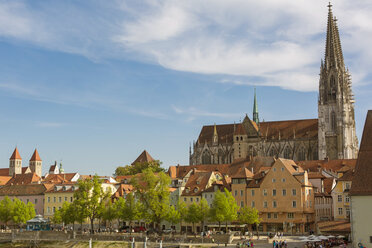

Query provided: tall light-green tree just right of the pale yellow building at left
[74,176,108,233]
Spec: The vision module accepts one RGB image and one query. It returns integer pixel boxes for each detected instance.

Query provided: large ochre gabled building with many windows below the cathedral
[246,158,314,233]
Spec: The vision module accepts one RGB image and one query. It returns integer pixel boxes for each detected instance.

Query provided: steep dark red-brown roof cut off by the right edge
[350,110,372,195]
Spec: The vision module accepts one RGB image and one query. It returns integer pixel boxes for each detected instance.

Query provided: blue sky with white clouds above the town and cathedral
[0,0,372,175]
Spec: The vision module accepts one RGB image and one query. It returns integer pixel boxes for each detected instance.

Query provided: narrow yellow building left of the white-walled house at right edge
[332,169,354,220]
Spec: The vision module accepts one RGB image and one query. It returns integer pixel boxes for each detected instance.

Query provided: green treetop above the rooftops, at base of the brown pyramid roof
[114,160,165,176]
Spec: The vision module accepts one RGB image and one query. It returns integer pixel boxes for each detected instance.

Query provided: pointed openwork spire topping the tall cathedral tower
[324,3,345,68]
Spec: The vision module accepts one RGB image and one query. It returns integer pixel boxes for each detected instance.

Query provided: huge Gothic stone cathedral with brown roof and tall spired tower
[189,5,358,165]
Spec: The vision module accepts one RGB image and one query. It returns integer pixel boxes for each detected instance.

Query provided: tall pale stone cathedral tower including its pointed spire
[318,4,358,159]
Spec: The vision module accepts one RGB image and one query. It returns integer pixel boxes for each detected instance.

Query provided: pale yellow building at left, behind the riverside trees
[44,183,78,219]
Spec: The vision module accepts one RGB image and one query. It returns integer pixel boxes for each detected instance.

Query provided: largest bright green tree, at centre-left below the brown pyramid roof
[131,168,171,231]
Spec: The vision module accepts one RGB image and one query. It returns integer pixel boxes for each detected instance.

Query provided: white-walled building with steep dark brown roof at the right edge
[350,110,372,248]
